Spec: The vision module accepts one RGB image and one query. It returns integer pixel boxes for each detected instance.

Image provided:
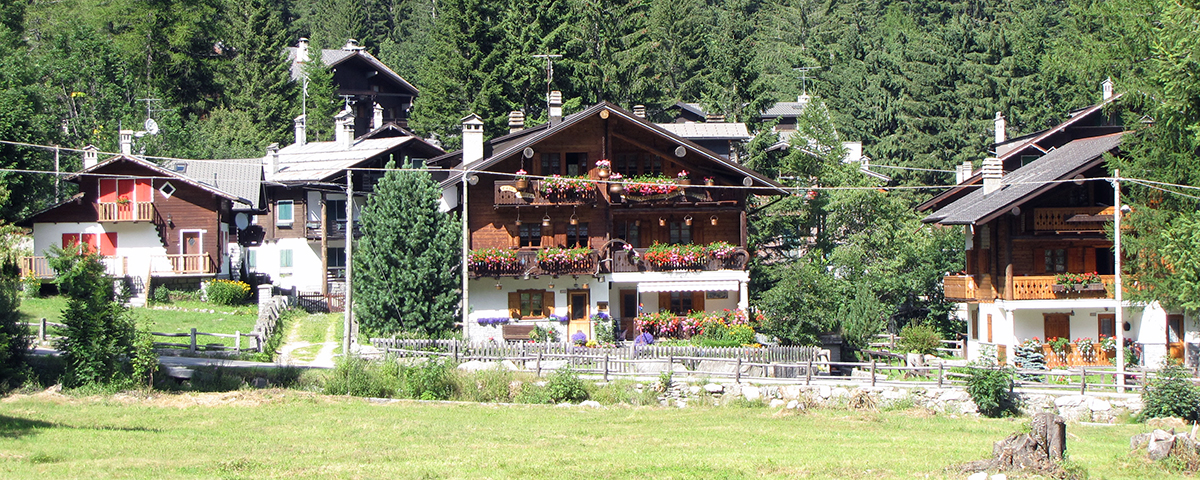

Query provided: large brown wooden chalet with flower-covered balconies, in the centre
[430,92,787,340]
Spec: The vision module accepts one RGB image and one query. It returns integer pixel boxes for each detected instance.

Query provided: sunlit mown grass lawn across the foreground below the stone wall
[0,390,1170,479]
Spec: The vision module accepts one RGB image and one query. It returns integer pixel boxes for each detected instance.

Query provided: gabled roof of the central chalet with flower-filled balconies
[431,102,791,194]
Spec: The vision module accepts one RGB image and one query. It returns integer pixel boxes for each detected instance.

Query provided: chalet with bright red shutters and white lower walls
[22,135,262,305]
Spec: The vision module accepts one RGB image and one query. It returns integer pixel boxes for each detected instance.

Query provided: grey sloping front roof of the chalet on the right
[923,132,1129,224]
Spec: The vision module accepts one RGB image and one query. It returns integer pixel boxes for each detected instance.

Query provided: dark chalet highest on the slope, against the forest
[287,38,418,138]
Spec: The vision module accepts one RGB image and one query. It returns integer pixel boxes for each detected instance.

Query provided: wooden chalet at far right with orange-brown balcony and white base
[918,82,1198,367]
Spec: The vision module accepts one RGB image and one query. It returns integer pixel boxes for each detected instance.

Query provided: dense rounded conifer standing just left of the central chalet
[353,162,462,335]
